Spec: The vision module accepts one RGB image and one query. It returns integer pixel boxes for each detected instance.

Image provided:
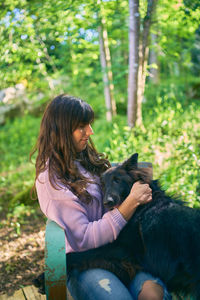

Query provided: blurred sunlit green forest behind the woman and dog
[0,0,200,290]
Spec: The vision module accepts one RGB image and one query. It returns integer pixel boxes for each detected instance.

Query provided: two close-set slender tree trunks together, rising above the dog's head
[127,0,157,127]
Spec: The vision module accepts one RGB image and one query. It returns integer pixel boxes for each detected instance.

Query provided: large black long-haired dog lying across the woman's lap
[67,154,200,300]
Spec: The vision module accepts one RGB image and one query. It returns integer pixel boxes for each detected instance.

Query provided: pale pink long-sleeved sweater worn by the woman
[36,163,127,253]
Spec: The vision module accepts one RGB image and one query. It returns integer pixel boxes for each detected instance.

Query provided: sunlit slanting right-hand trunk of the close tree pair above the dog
[137,0,157,126]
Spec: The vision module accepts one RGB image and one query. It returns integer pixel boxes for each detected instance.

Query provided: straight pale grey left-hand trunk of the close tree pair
[127,0,140,127]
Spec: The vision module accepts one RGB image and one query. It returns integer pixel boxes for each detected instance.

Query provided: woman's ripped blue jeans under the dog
[67,269,172,300]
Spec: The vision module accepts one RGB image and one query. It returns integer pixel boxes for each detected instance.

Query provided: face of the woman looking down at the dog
[72,124,94,152]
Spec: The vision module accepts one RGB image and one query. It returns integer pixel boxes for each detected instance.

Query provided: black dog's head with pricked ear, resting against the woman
[101,153,150,208]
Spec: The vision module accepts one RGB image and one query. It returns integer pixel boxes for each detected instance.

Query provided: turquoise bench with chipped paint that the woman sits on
[45,162,192,300]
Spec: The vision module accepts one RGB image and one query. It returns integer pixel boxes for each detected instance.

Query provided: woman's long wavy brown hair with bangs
[30,94,110,203]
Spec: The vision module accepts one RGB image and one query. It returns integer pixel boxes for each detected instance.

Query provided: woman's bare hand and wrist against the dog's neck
[118,181,152,221]
